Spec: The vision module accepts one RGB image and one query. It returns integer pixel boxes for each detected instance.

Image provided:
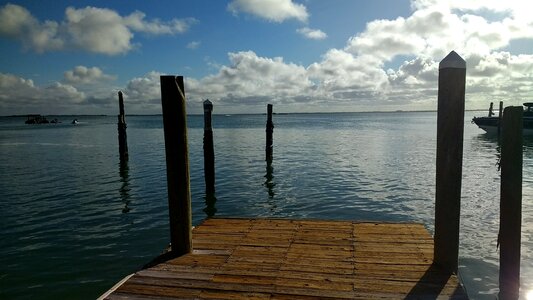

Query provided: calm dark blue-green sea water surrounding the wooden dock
[0,112,533,299]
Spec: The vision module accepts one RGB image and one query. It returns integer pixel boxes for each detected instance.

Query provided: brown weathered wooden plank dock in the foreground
[101,219,467,299]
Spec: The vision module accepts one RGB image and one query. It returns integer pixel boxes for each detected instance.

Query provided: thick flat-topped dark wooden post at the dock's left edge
[160,76,192,257]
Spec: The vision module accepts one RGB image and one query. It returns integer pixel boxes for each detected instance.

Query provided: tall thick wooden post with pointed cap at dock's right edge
[434,51,466,273]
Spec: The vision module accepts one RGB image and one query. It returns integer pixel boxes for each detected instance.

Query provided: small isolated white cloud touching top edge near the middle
[228,0,309,23]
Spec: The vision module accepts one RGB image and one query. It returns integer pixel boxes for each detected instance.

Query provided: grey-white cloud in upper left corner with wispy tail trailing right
[0,4,197,55]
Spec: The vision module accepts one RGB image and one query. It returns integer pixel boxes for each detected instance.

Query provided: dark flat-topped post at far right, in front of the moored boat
[498,106,523,299]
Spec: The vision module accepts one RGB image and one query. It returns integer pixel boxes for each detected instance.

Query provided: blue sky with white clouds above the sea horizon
[0,0,533,115]
